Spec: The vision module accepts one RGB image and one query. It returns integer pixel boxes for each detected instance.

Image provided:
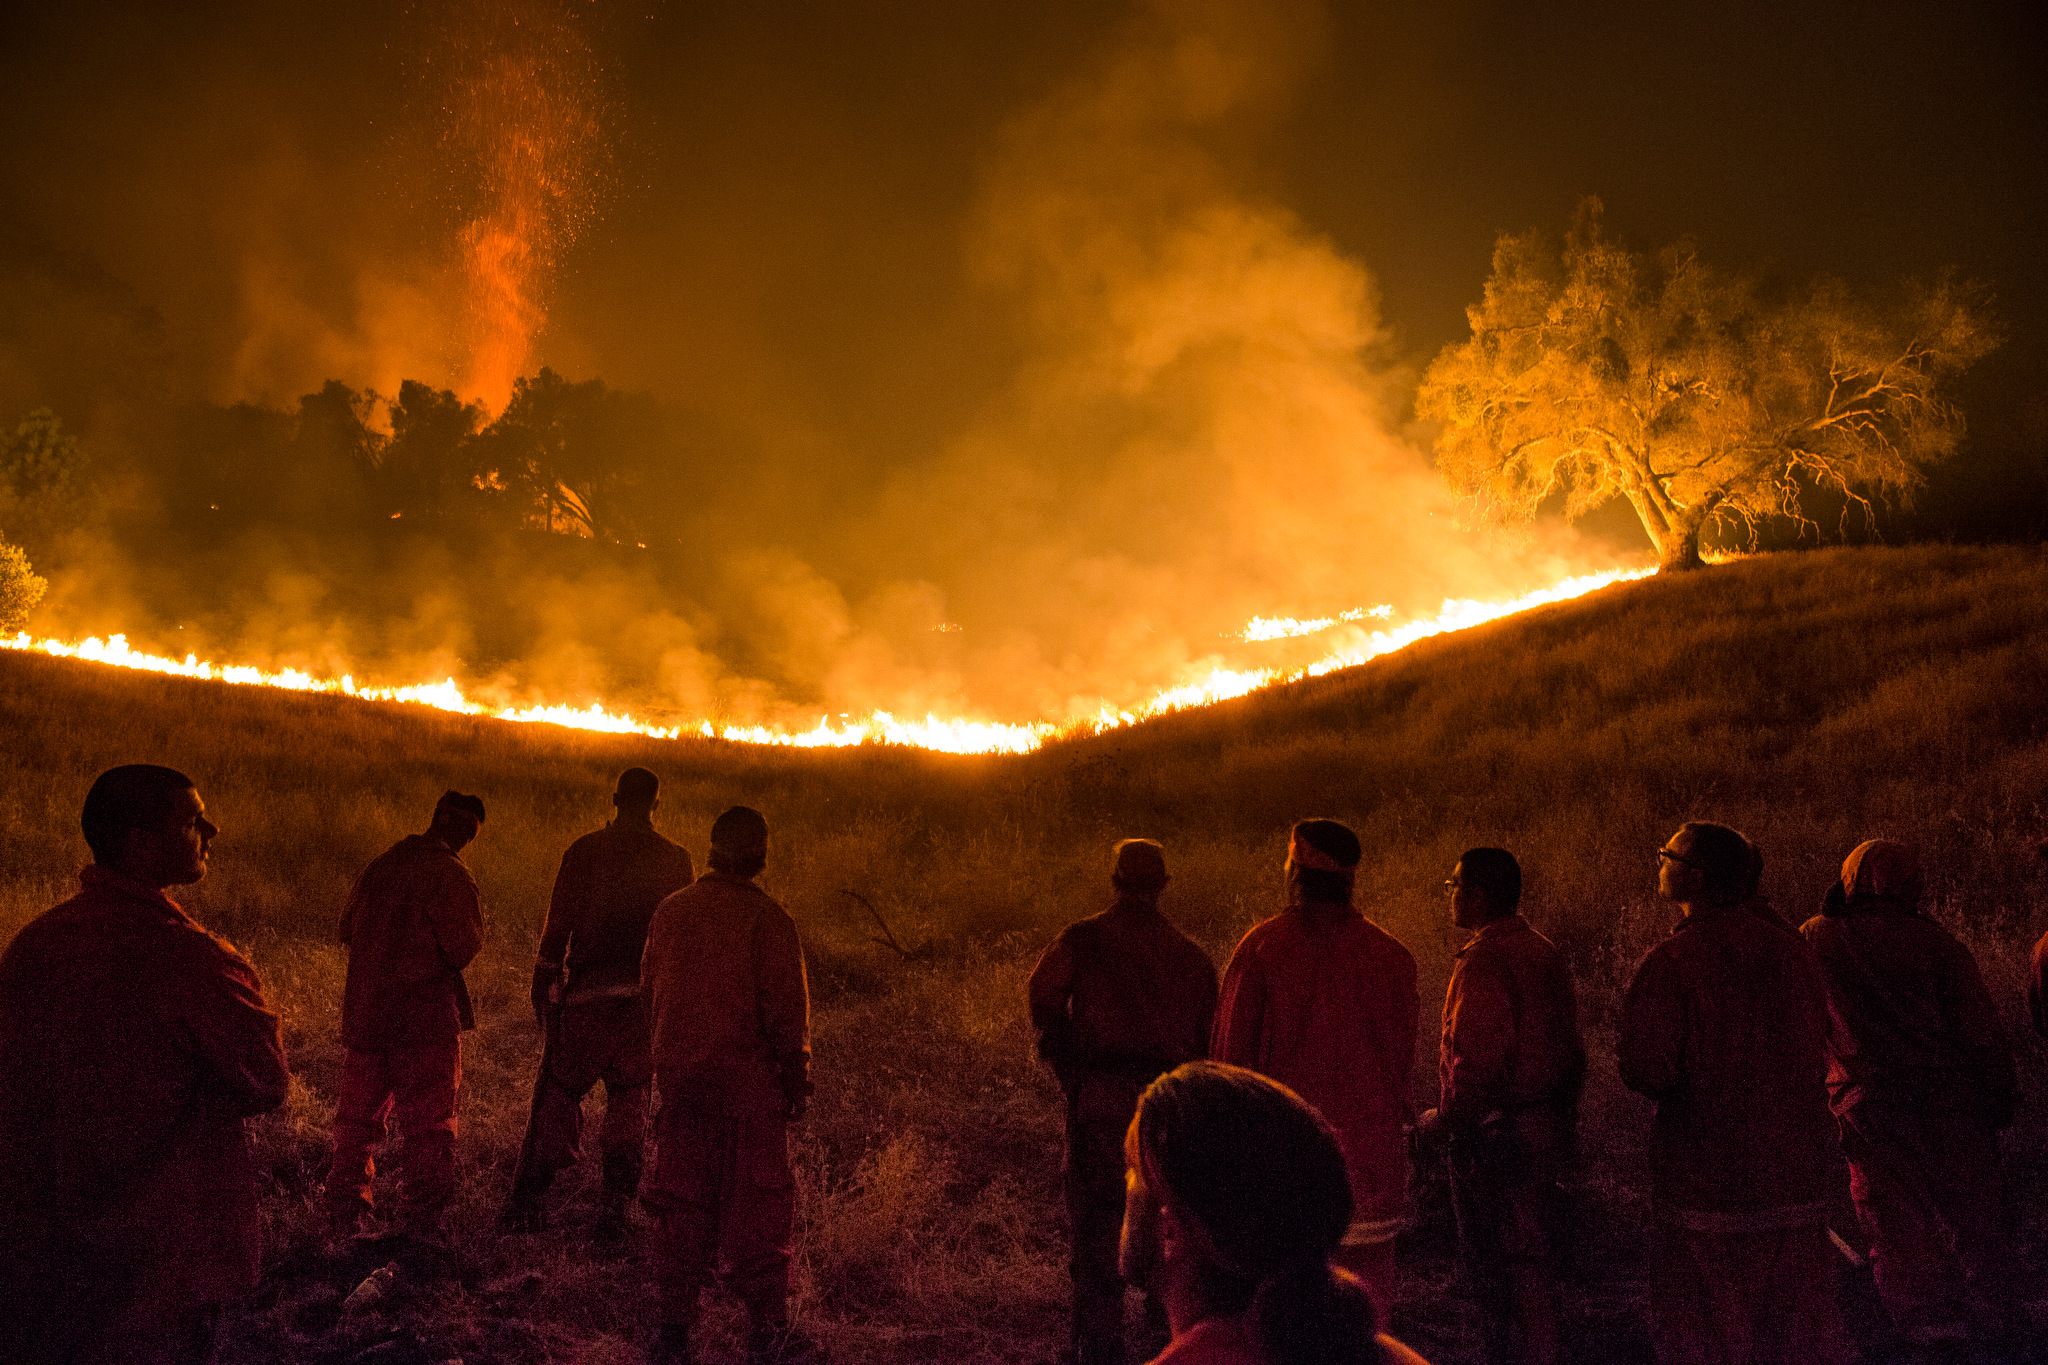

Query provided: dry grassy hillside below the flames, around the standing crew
[0,548,2048,1365]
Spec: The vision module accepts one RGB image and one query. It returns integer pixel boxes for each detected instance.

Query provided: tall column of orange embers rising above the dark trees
[440,0,608,409]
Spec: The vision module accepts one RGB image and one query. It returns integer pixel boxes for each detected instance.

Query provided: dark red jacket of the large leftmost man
[0,868,291,1355]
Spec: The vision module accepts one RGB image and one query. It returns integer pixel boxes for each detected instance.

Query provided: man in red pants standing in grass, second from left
[328,792,483,1236]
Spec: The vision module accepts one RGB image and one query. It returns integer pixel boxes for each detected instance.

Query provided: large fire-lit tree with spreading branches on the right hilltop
[1415,199,1995,565]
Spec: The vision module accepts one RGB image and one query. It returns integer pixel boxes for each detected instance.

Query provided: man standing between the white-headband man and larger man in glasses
[1419,849,1585,1365]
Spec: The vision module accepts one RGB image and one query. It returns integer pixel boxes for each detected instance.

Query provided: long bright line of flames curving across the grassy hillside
[0,569,1655,753]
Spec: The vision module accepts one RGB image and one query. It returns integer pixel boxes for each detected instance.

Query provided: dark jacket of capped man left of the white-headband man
[1030,898,1217,1089]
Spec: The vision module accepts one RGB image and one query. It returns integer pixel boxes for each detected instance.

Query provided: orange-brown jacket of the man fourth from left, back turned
[641,872,811,1117]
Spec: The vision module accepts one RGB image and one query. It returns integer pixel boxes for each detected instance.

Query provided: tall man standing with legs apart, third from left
[502,767,694,1240]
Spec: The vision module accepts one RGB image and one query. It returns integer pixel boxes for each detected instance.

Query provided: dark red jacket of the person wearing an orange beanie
[1800,896,2019,1128]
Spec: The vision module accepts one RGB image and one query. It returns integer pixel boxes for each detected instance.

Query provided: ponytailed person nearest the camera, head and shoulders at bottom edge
[1122,1062,1427,1365]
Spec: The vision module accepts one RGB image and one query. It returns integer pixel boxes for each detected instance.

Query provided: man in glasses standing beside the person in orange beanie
[1618,821,1847,1365]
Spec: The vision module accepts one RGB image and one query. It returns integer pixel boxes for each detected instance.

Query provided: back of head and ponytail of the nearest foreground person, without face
[1133,1062,1380,1365]
